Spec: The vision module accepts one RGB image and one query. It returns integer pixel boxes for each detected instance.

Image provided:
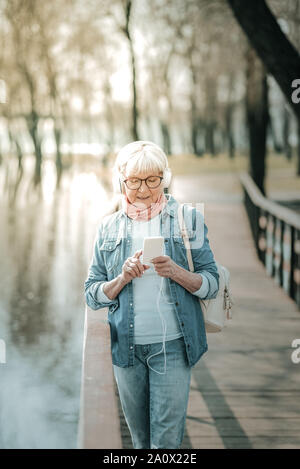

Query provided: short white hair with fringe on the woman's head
[113,140,168,190]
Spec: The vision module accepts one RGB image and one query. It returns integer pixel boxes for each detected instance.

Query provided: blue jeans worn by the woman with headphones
[113,337,191,449]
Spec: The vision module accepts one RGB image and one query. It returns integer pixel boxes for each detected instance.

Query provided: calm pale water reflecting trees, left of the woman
[0,155,111,449]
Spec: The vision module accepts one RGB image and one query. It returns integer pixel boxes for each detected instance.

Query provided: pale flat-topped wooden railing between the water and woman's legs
[77,307,122,449]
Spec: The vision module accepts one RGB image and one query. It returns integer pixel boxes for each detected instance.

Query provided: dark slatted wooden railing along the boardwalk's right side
[240,173,300,308]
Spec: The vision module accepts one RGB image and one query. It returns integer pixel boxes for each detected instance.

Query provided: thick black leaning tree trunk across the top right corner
[227,0,300,119]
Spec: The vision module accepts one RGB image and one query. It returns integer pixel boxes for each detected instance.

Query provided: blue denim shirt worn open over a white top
[85,194,219,368]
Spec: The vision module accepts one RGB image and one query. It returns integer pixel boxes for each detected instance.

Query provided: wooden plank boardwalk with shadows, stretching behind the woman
[119,174,300,449]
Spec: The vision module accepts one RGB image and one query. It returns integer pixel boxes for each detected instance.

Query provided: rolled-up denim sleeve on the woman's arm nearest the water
[84,225,119,310]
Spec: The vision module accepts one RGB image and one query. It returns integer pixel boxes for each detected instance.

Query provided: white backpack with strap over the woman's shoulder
[178,204,233,332]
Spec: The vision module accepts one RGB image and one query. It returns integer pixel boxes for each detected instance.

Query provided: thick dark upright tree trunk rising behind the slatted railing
[246,48,269,195]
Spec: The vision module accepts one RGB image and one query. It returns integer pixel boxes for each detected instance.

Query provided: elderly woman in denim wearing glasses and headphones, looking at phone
[85,141,219,449]
